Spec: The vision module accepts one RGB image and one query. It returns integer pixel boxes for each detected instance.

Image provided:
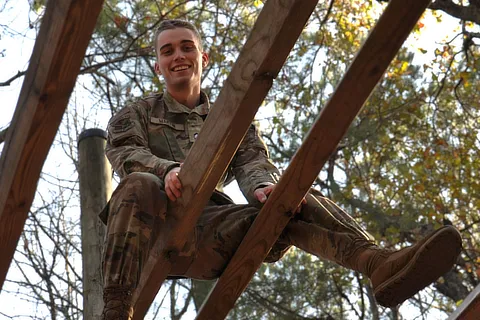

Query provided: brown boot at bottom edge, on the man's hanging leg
[102,285,133,320]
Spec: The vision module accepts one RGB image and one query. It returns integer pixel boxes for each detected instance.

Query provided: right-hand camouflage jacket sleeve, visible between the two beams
[231,124,280,203]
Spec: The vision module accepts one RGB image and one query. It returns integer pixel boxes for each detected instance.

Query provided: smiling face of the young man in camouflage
[155,28,208,92]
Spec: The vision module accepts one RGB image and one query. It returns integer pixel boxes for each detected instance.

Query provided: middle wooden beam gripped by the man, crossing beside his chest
[133,0,318,319]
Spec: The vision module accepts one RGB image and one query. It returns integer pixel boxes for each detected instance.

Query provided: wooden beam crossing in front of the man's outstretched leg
[197,0,430,320]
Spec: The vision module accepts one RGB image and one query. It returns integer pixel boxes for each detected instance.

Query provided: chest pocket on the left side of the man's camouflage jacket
[148,117,185,162]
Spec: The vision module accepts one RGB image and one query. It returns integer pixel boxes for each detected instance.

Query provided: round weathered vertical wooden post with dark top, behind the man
[78,129,112,320]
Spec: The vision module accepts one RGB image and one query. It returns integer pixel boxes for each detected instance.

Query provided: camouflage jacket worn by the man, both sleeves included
[106,92,279,203]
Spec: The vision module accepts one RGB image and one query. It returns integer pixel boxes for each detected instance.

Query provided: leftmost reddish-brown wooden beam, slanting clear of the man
[0,0,103,287]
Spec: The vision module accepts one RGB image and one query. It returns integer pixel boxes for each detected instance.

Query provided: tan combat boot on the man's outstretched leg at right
[367,226,462,307]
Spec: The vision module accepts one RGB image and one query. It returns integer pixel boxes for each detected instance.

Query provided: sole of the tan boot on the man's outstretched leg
[374,227,462,308]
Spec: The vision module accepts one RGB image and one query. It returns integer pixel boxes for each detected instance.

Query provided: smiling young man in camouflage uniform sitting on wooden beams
[101,20,461,319]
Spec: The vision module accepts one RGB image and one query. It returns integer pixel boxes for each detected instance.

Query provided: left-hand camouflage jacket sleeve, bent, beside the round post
[105,104,180,179]
